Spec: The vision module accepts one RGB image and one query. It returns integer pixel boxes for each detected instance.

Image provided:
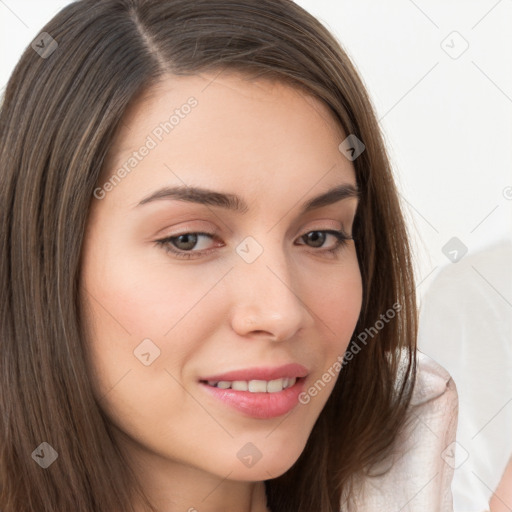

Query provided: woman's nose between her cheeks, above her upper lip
[229,242,314,341]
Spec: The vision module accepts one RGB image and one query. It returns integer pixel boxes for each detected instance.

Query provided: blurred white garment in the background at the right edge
[418,241,512,512]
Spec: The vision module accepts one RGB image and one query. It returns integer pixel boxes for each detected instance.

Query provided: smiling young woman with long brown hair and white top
[0,0,456,512]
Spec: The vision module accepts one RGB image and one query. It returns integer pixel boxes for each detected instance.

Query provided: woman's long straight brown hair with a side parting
[0,0,417,512]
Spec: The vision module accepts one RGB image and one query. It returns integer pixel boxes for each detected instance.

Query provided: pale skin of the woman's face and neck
[81,73,362,512]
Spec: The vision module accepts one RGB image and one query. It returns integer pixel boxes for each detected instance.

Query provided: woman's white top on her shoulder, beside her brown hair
[342,352,458,512]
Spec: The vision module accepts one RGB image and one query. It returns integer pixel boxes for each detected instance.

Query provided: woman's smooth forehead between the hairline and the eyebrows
[100,72,355,209]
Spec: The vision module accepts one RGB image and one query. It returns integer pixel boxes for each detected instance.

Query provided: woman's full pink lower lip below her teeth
[200,378,304,419]
